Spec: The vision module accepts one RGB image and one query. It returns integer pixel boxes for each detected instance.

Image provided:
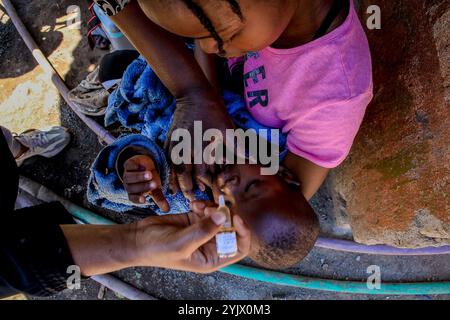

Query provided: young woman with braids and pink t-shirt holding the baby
[96,0,372,199]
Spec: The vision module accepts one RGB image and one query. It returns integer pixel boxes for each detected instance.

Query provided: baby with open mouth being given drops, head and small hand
[118,144,318,269]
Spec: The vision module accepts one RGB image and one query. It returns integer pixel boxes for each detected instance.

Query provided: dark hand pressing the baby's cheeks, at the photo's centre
[165,93,234,200]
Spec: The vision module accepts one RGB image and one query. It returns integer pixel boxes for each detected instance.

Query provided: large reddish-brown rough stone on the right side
[331,0,450,247]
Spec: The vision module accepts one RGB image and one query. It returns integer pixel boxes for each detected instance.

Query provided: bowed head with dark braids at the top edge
[139,0,299,57]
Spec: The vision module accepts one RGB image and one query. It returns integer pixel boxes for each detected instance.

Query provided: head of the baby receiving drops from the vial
[213,165,319,269]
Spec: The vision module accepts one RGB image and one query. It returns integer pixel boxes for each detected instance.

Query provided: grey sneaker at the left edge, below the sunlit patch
[14,126,70,166]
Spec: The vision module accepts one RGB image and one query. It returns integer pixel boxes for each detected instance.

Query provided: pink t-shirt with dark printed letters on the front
[229,1,373,168]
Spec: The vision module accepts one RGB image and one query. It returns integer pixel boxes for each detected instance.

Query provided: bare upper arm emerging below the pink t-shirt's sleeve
[283,152,330,200]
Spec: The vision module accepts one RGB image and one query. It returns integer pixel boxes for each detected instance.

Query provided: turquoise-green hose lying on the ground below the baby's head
[64,201,450,295]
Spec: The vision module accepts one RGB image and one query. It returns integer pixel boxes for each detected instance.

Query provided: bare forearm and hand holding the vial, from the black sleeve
[61,202,250,276]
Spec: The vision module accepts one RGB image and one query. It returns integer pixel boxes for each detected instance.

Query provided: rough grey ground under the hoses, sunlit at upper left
[0,0,450,300]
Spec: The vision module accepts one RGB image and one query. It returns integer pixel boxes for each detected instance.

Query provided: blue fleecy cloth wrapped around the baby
[88,57,287,214]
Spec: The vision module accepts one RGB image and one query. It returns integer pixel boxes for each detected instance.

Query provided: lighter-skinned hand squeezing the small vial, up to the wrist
[133,202,250,273]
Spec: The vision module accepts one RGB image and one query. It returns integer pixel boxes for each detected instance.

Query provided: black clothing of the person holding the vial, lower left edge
[0,133,74,297]
